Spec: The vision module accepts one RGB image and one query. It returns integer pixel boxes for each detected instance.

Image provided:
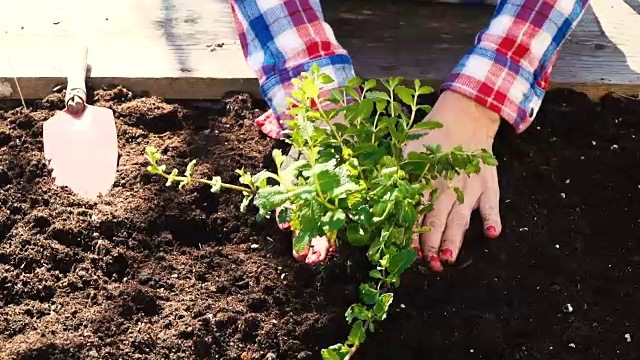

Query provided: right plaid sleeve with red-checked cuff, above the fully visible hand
[441,0,588,133]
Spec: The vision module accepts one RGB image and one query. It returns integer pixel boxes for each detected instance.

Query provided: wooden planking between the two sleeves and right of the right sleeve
[324,0,640,98]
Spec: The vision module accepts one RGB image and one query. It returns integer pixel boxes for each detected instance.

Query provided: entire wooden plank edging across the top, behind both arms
[0,0,640,99]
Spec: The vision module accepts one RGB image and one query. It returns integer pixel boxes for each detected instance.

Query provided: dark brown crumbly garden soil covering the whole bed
[0,89,640,360]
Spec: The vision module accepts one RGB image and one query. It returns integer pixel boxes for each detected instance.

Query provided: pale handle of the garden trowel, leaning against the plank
[64,45,88,114]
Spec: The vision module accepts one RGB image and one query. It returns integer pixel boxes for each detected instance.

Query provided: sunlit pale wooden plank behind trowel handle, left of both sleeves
[0,0,259,99]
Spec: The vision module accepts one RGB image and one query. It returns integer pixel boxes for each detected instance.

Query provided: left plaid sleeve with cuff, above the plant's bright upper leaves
[230,0,355,122]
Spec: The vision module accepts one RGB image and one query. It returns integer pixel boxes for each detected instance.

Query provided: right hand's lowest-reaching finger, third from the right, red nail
[420,189,456,272]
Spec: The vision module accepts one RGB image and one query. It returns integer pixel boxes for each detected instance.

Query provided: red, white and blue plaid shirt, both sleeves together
[230,0,588,133]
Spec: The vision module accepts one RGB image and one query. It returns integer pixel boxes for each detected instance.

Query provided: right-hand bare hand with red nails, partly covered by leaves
[405,91,502,272]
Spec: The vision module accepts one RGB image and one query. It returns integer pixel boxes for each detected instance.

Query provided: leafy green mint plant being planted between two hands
[145,66,497,360]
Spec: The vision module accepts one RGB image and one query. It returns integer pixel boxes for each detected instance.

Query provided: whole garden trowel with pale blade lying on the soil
[43,46,118,200]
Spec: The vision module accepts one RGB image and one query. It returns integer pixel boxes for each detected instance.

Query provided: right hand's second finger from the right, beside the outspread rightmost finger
[440,181,481,264]
